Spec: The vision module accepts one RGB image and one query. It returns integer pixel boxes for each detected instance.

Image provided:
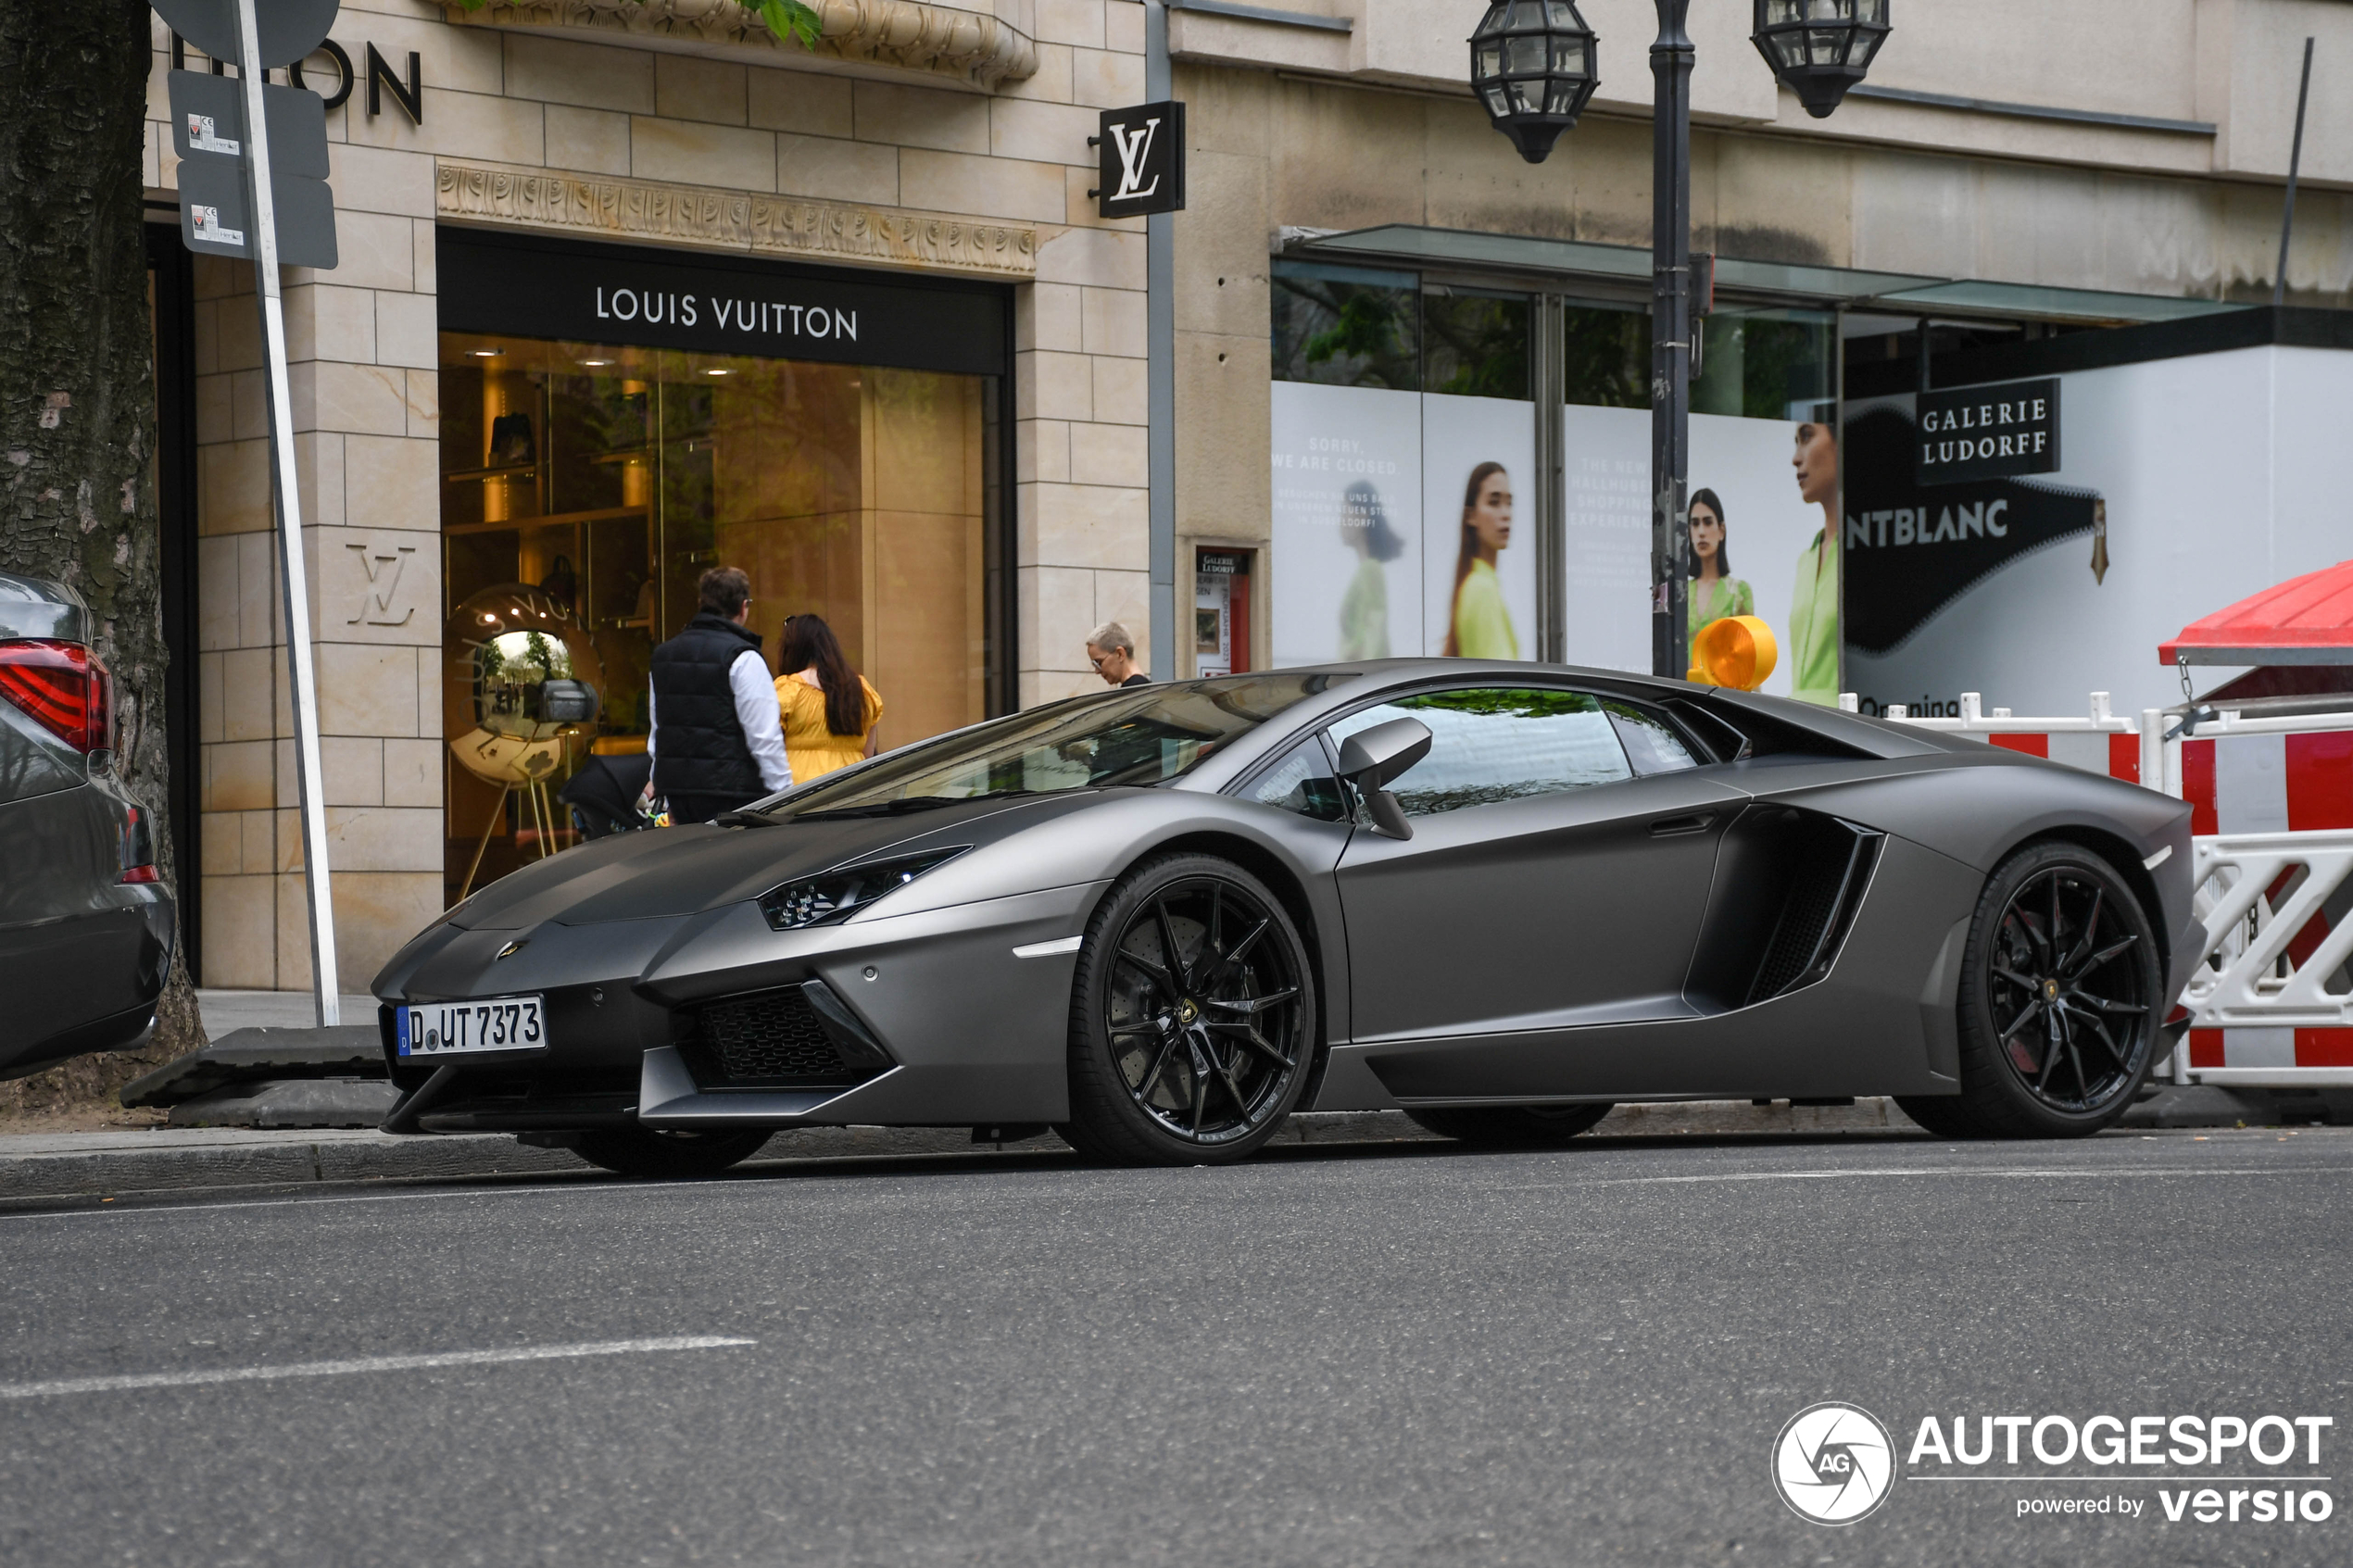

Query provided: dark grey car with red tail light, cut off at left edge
[0,571,174,1077]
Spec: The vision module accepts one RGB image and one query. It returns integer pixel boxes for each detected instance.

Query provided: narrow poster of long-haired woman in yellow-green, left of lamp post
[1398,393,1537,659]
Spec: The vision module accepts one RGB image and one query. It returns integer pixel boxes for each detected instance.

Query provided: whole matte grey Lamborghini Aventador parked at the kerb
[374,660,2205,1173]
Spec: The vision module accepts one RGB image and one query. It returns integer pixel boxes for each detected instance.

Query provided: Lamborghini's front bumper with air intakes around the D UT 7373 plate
[379,882,1106,1133]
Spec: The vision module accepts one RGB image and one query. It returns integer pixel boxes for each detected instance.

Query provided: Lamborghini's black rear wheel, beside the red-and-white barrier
[1896,844,2162,1138]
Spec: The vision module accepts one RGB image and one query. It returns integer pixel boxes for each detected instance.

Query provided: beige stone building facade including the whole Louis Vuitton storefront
[144,0,1149,992]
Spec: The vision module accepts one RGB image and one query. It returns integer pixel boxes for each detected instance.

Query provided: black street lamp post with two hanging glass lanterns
[1471,0,1887,680]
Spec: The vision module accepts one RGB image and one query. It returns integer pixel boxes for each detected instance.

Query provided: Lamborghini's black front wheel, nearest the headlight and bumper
[1063,856,1315,1166]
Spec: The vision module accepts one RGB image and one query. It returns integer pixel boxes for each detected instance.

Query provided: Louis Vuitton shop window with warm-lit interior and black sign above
[440,231,1012,900]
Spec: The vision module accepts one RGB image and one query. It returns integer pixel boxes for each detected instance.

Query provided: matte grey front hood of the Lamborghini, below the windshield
[447,790,1097,931]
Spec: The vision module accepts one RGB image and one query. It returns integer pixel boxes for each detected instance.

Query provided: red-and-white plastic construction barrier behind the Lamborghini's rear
[1840,691,2353,1088]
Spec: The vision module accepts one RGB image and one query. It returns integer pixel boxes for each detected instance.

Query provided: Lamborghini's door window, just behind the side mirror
[1332,686,1633,816]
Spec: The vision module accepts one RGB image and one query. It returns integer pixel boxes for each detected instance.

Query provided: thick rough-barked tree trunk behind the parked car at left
[0,0,202,1110]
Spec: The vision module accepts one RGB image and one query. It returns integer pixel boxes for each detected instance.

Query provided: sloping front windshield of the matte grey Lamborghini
[753,672,1353,818]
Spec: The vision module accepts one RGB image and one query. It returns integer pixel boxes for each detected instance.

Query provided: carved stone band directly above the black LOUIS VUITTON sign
[433,159,1038,278]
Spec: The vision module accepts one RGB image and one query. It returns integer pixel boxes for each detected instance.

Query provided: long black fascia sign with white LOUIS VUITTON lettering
[435,228,1010,376]
